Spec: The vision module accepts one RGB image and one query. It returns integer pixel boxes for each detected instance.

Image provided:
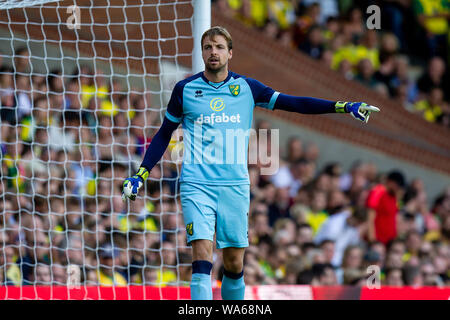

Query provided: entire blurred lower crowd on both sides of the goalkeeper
[0,12,450,286]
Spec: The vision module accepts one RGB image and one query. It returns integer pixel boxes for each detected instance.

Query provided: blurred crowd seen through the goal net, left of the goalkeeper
[0,48,174,285]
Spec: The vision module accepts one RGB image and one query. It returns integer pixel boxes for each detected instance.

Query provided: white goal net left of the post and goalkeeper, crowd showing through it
[0,0,194,299]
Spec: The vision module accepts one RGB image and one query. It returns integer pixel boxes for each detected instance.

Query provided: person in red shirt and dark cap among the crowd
[366,171,405,245]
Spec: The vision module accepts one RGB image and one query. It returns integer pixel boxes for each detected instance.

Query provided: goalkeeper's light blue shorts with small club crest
[180,182,250,249]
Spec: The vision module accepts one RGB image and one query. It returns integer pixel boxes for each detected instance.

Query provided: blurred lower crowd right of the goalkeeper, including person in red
[244,121,450,287]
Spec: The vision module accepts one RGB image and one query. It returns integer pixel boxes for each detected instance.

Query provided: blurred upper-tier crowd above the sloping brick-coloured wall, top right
[214,0,450,127]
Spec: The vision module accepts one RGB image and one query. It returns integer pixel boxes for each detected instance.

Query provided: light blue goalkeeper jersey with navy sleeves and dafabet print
[166,72,279,185]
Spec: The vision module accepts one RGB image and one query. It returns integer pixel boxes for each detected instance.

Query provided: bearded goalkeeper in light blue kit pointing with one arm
[122,27,379,300]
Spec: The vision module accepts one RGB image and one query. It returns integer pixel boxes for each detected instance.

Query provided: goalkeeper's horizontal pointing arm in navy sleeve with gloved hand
[274,93,380,122]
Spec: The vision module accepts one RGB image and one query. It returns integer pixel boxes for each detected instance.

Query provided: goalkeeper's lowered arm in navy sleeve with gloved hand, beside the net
[122,117,179,201]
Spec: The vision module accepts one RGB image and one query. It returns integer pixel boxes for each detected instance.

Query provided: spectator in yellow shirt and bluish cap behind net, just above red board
[97,243,127,286]
